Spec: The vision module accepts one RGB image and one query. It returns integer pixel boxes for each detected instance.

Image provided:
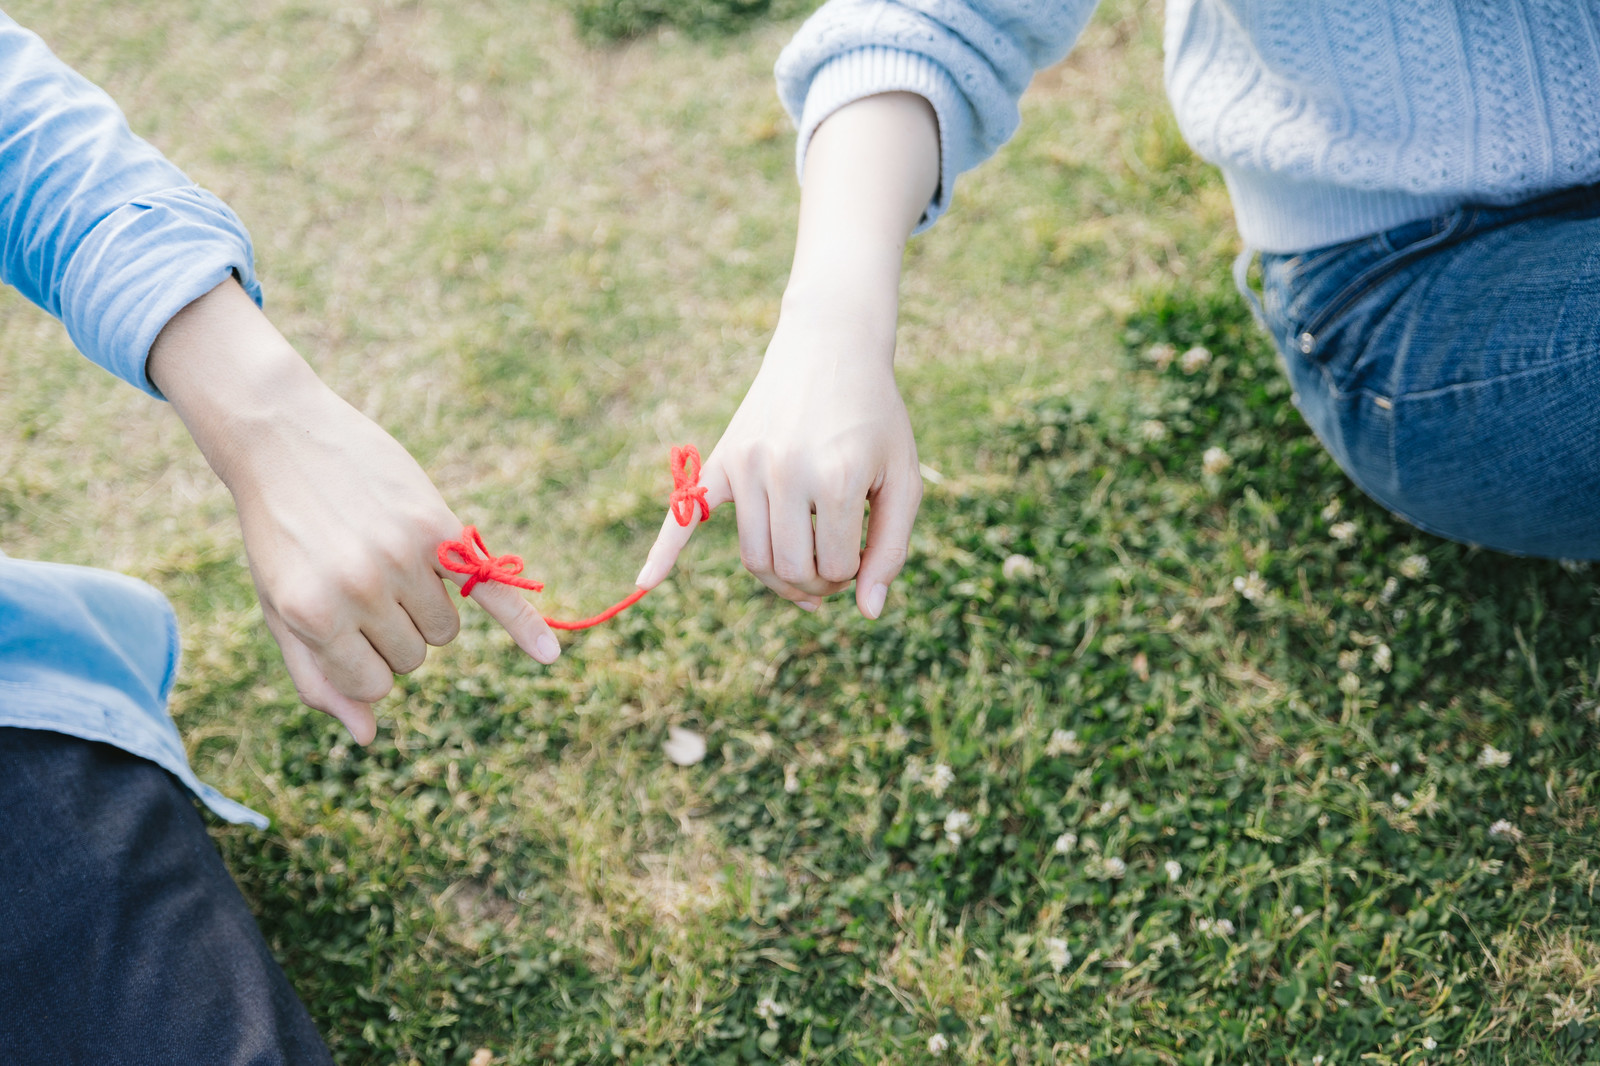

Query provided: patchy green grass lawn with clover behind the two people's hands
[9,0,1600,1066]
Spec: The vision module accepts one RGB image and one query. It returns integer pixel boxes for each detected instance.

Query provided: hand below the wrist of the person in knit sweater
[638,296,922,618]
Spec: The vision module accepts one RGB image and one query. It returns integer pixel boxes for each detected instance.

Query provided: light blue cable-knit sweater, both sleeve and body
[778,0,1600,251]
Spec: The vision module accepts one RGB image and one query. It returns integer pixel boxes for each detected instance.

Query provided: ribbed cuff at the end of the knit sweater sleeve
[795,46,974,234]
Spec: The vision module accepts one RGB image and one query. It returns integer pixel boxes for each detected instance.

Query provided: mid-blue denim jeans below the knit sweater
[1261,186,1600,559]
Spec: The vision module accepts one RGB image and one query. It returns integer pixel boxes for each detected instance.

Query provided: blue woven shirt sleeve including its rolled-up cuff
[0,14,261,395]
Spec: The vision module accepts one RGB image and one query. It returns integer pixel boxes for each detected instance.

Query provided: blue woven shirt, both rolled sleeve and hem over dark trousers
[0,14,267,826]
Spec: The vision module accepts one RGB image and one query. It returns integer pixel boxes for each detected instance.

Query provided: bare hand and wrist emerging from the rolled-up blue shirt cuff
[146,280,560,744]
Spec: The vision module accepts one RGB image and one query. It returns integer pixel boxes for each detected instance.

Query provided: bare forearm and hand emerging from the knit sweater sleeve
[638,93,939,618]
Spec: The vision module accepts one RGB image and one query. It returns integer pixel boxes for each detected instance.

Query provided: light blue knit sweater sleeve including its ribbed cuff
[776,0,1098,232]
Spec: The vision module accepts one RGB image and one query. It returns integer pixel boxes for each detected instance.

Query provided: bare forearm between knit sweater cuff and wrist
[784,93,939,344]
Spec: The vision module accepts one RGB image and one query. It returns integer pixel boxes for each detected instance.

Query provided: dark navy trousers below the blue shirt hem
[0,728,333,1066]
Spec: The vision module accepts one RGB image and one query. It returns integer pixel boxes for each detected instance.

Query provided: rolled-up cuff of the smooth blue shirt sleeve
[61,186,261,397]
